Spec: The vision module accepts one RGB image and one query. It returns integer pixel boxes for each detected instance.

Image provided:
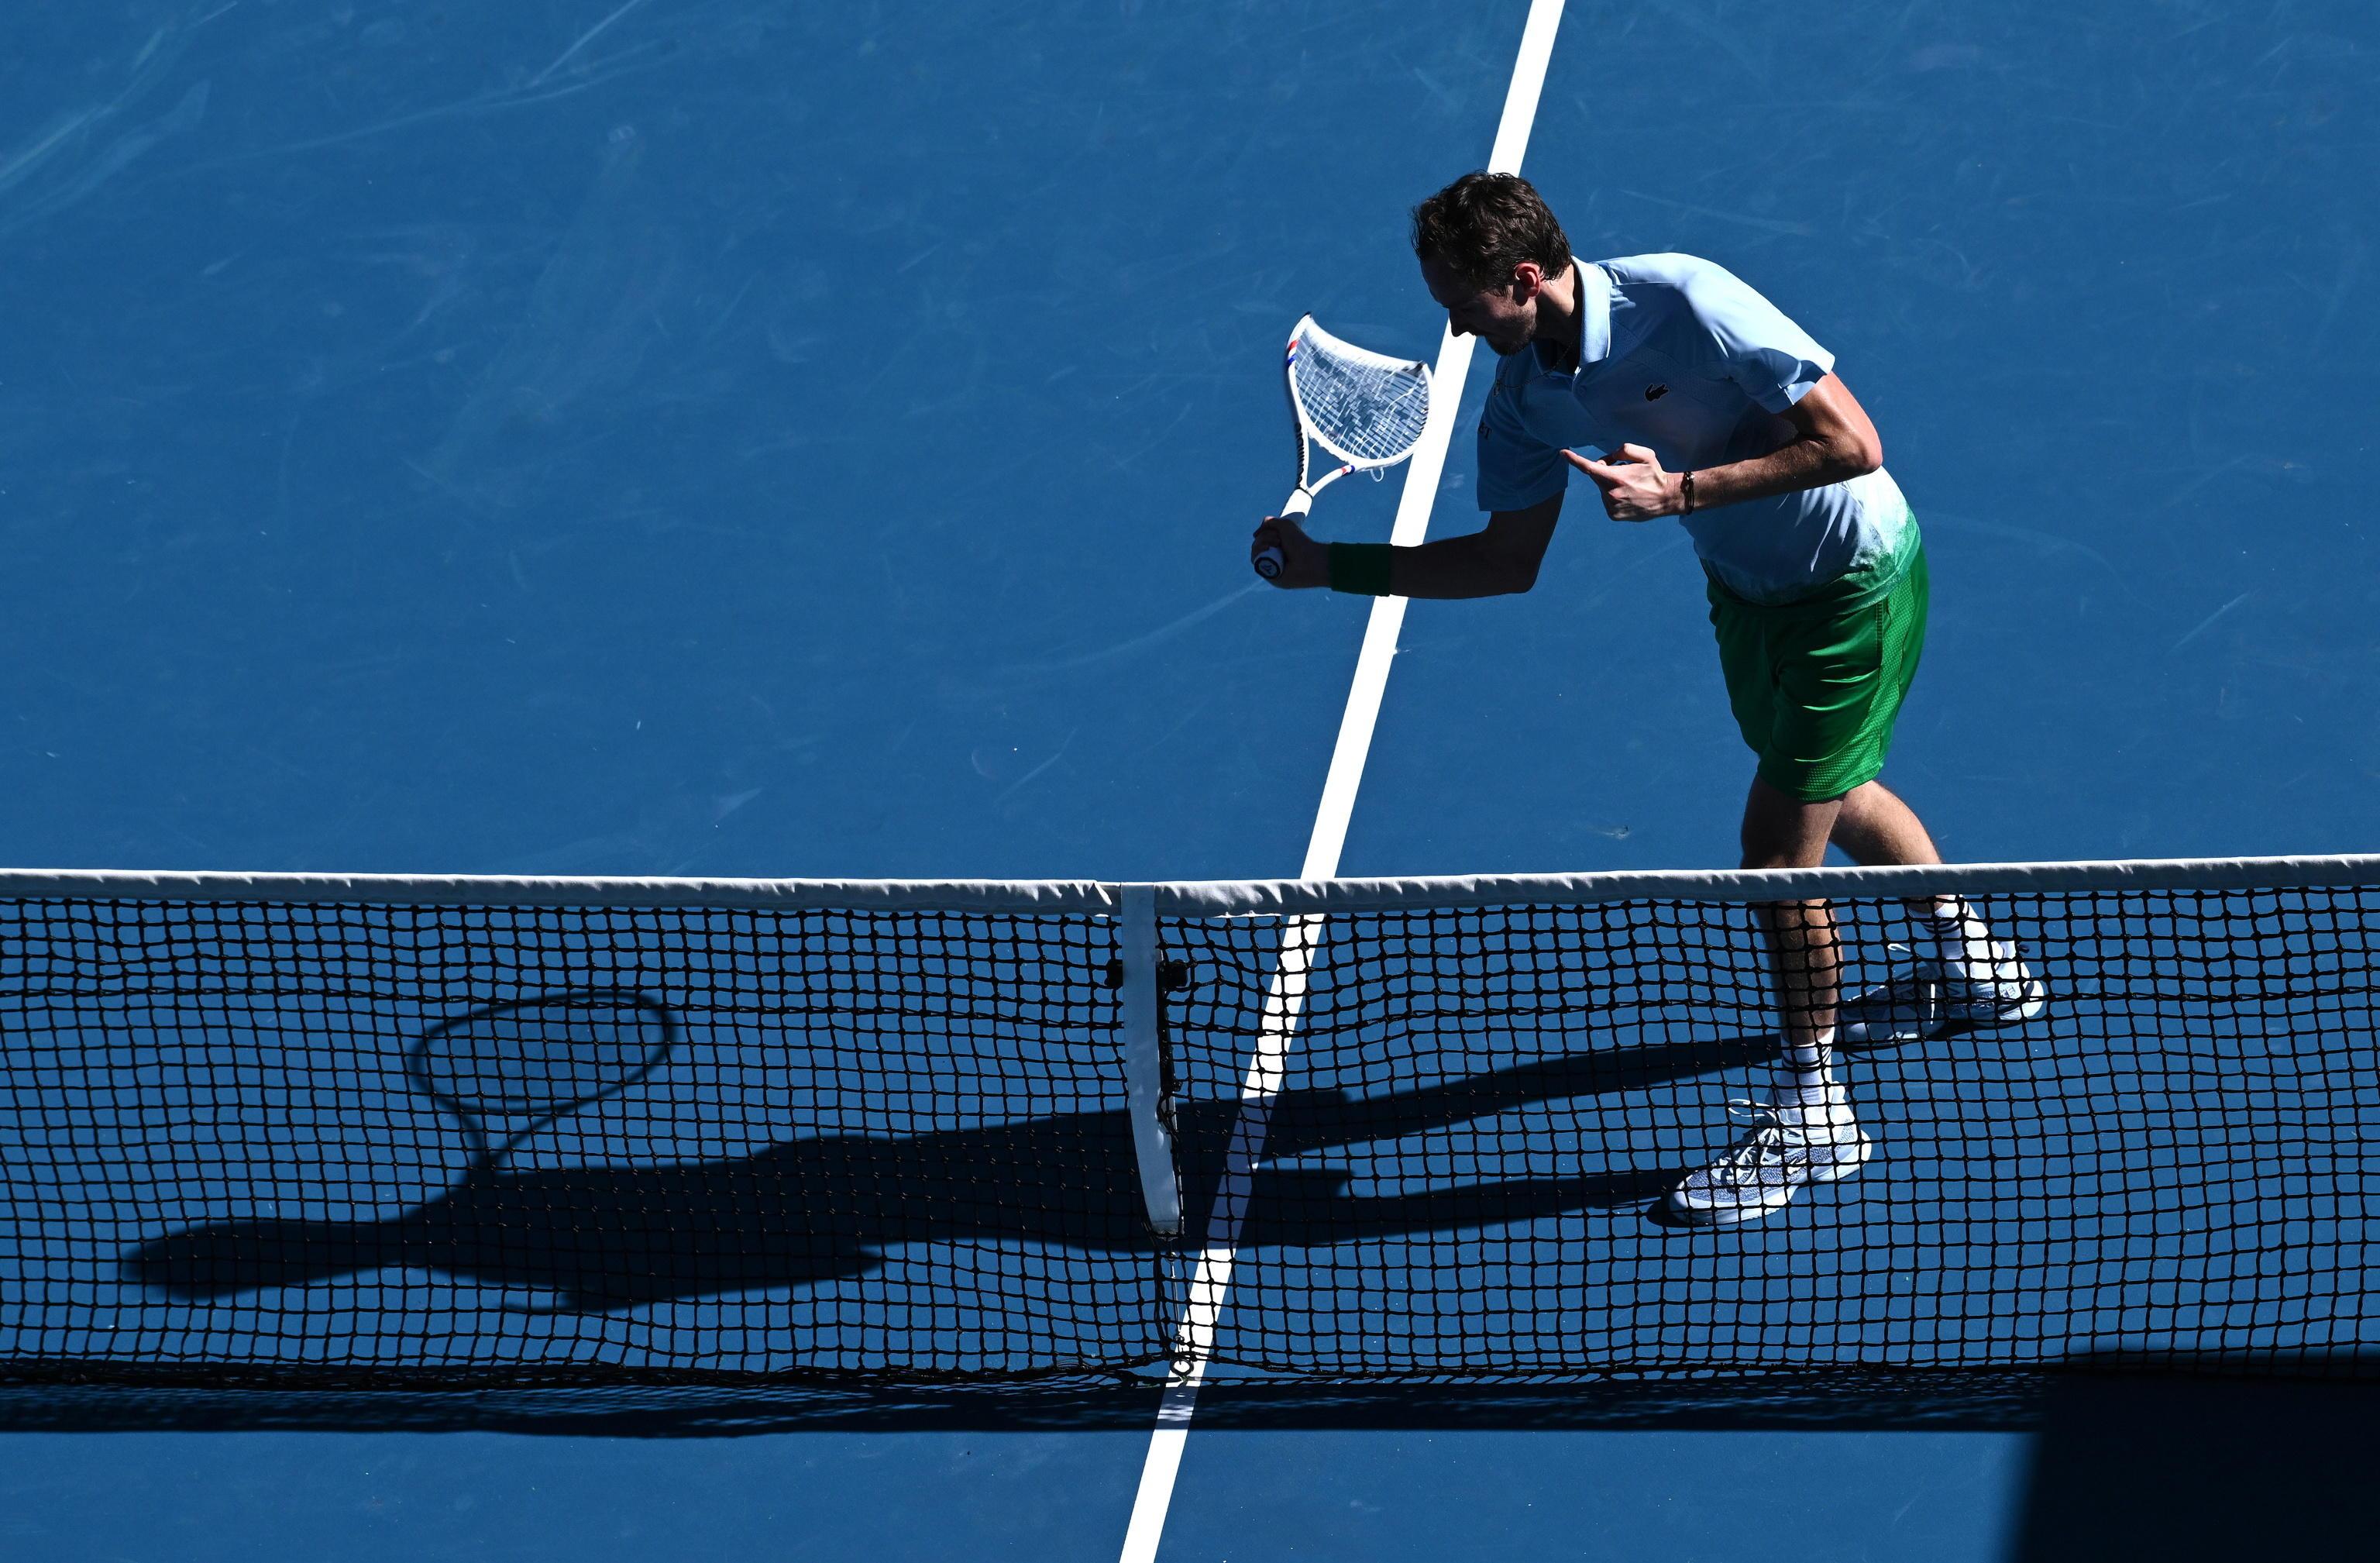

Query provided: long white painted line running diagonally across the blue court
[1123,0,1561,1563]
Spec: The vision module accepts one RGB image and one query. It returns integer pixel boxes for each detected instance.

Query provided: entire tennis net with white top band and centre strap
[0,859,2380,1389]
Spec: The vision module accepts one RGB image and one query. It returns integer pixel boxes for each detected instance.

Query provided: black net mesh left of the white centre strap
[0,902,1168,1382]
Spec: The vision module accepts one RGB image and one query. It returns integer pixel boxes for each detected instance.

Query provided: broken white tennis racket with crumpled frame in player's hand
[1254,314,1430,580]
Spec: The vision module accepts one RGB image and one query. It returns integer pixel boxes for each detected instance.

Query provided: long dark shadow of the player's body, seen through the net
[124,1013,1776,1311]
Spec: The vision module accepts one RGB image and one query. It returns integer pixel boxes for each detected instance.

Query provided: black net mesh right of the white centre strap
[1168,890,2380,1378]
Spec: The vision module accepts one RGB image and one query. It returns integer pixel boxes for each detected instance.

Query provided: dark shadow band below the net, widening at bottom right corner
[19,1358,2380,1437]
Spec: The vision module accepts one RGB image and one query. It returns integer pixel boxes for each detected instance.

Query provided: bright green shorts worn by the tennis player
[1711,531,1925,802]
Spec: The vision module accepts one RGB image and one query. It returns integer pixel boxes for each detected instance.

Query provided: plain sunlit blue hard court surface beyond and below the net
[0,0,2380,1563]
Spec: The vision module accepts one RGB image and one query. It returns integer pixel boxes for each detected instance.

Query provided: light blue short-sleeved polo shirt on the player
[1478,254,1916,602]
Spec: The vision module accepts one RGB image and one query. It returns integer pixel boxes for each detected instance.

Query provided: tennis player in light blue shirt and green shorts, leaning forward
[1252,174,2045,1225]
